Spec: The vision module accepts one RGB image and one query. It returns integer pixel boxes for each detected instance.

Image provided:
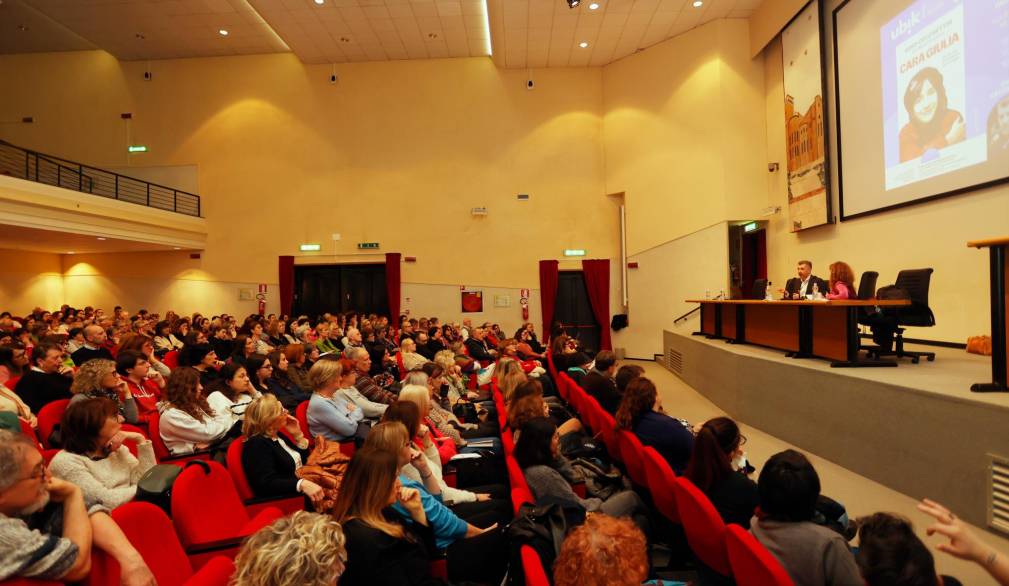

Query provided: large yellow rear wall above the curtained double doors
[0,51,618,308]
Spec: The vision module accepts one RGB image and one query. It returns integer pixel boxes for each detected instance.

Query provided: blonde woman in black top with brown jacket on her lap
[242,394,324,502]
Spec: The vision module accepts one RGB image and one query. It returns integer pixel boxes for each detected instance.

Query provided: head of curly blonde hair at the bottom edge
[231,510,347,586]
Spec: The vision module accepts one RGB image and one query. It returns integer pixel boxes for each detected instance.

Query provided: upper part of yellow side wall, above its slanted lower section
[602,19,767,256]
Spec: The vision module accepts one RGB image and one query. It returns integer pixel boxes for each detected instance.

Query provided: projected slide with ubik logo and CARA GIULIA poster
[880,0,1005,191]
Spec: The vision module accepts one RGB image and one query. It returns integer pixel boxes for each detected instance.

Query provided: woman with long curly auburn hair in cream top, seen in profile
[158,366,234,456]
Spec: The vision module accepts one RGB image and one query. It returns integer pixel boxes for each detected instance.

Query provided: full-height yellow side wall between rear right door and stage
[602,19,767,358]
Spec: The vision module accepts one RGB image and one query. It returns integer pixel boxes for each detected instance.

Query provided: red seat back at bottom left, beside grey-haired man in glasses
[87,502,193,586]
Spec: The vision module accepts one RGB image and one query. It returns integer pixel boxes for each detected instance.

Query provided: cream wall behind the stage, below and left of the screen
[764,1,1009,343]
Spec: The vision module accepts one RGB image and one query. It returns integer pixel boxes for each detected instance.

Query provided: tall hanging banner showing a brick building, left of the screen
[781,0,829,232]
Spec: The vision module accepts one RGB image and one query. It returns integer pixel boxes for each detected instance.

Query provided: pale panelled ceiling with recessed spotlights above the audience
[0,0,761,69]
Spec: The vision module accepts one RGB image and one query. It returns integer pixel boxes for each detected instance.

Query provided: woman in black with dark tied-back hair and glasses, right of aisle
[685,418,760,528]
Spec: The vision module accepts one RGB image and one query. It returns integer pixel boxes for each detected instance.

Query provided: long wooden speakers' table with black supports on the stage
[687,300,911,366]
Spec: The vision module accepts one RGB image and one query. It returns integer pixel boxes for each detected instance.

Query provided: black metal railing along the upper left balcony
[0,140,202,217]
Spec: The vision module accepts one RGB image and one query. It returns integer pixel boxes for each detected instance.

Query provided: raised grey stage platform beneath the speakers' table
[662,324,1009,531]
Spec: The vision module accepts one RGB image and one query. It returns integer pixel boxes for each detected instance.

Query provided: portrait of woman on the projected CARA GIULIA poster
[900,68,966,162]
